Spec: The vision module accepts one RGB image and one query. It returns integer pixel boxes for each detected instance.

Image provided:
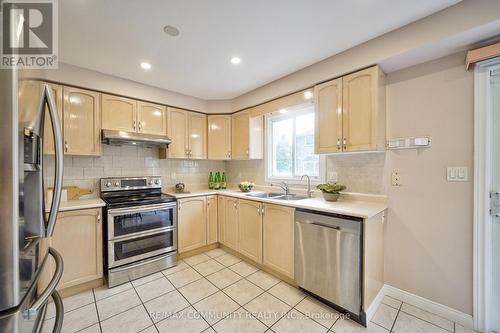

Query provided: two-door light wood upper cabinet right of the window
[314,66,385,154]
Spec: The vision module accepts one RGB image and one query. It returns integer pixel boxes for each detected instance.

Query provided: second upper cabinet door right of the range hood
[188,112,207,159]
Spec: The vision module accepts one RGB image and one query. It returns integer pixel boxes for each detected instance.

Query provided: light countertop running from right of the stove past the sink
[165,189,387,219]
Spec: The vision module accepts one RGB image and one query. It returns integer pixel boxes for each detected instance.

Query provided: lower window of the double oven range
[113,231,174,261]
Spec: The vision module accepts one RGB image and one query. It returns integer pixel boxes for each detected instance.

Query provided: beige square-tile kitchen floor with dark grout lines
[44,249,472,333]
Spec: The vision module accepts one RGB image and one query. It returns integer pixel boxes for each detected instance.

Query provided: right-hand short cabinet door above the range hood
[137,102,167,135]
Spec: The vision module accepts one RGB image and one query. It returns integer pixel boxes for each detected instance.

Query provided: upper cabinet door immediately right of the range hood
[167,108,188,158]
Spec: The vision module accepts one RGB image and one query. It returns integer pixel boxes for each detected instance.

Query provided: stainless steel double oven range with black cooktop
[101,177,177,288]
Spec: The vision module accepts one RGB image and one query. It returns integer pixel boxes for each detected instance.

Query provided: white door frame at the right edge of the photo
[473,58,500,332]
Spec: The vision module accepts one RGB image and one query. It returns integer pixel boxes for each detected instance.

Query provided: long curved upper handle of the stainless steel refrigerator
[42,83,64,237]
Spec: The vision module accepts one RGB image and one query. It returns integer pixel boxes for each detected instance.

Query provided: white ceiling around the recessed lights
[59,0,460,100]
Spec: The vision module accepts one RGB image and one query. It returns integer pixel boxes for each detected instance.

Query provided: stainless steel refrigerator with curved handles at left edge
[0,62,64,333]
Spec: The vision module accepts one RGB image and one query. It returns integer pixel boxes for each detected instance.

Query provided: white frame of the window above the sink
[264,102,326,185]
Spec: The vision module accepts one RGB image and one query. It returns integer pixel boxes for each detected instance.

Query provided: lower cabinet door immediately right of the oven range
[177,197,207,253]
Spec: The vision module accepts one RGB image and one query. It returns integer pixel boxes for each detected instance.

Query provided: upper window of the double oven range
[113,208,174,237]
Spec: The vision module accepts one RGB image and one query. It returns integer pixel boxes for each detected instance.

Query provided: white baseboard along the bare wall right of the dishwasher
[380,284,473,329]
